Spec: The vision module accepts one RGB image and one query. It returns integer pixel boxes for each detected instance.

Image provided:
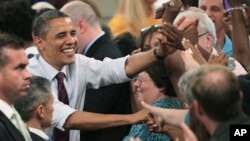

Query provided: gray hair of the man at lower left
[14,76,52,122]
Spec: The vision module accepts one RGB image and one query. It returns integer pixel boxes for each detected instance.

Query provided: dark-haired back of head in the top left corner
[0,0,36,46]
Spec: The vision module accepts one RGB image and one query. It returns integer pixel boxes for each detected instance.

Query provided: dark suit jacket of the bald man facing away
[81,35,131,141]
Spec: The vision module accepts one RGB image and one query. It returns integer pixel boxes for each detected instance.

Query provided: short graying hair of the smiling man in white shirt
[32,9,68,39]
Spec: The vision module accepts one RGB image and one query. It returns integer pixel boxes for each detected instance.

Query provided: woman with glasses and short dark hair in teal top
[124,60,181,141]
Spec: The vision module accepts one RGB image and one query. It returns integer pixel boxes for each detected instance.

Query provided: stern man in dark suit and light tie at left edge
[0,34,31,141]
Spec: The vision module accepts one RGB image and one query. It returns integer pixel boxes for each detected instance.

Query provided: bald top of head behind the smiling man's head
[60,1,98,25]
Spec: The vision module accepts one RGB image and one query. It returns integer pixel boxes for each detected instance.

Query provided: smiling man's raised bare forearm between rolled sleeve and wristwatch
[125,50,157,77]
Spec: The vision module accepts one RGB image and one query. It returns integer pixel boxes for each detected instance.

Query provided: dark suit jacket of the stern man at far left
[0,111,25,141]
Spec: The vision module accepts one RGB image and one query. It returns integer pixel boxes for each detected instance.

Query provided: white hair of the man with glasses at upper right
[174,9,217,47]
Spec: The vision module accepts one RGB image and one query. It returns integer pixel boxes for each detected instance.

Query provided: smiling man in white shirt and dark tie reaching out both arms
[28,10,173,141]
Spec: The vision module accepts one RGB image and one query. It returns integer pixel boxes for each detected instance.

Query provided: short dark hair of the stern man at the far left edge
[0,33,24,68]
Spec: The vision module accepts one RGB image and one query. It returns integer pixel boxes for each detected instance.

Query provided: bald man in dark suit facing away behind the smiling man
[61,1,131,141]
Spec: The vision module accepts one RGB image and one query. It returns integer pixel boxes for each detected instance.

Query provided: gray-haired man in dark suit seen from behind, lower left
[14,76,54,141]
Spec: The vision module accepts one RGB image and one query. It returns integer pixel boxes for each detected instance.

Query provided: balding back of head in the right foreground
[191,65,242,122]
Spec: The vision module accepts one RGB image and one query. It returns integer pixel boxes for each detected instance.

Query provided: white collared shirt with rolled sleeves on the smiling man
[28,54,130,141]
